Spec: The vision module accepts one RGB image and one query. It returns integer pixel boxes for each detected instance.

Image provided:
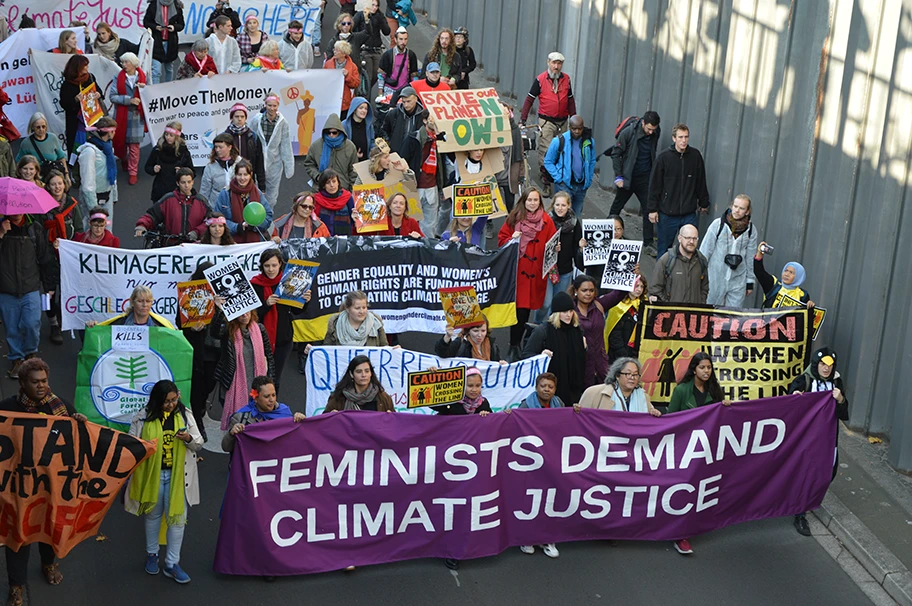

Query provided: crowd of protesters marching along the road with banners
[0,0,847,604]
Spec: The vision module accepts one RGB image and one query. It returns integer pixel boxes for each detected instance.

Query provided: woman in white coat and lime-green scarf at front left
[124,379,203,584]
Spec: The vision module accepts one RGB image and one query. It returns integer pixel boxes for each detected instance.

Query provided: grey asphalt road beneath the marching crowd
[0,5,868,606]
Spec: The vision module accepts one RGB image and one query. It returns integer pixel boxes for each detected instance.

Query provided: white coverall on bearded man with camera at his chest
[700,217,759,307]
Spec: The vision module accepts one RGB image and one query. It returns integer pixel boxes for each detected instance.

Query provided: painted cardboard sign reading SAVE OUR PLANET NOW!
[420,88,513,153]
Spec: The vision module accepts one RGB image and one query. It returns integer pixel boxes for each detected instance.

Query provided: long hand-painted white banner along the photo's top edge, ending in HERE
[0,0,320,42]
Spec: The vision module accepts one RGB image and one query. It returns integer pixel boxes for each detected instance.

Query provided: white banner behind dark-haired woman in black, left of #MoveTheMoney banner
[30,49,120,145]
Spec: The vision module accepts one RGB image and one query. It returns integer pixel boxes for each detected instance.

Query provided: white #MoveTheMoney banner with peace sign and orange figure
[140,69,343,166]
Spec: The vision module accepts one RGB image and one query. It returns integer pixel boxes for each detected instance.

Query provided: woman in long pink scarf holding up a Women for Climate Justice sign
[215,314,275,431]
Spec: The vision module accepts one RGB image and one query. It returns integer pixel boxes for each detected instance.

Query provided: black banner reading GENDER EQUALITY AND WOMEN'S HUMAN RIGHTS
[279,236,519,341]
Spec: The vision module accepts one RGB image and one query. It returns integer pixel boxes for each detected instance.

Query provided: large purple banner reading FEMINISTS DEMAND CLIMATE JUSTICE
[215,393,836,576]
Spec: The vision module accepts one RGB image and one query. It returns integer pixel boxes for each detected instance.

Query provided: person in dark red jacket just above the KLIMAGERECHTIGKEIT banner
[134,167,209,244]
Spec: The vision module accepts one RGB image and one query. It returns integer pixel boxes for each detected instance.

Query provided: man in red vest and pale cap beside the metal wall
[519,52,576,198]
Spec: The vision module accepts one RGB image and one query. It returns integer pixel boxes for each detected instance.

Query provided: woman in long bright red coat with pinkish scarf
[497,187,557,361]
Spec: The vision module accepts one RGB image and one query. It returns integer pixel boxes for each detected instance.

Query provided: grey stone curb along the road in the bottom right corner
[813,492,912,606]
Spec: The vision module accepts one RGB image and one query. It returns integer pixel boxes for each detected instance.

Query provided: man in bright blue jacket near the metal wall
[545,116,598,217]
